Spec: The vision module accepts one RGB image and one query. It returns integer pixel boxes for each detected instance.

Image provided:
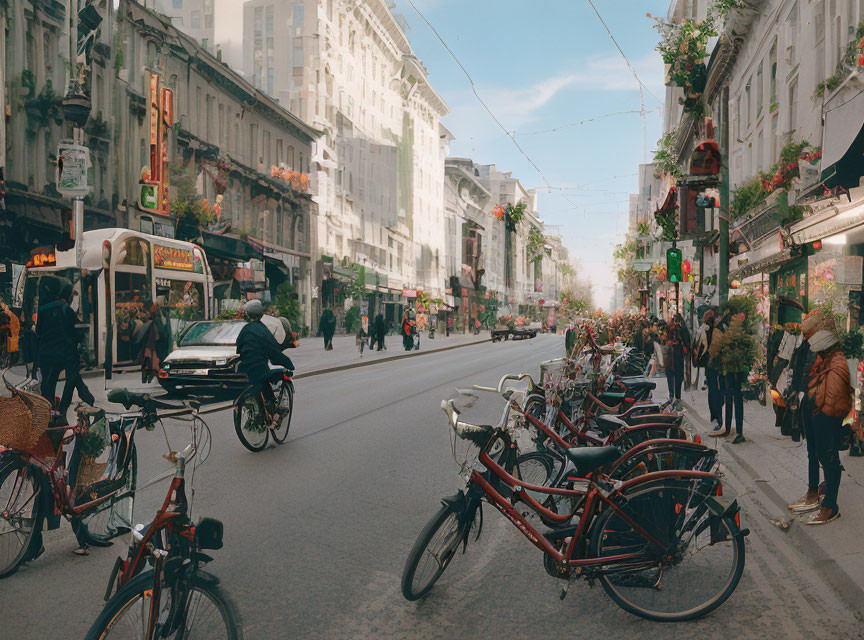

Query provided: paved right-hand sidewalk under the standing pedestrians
[680,385,864,613]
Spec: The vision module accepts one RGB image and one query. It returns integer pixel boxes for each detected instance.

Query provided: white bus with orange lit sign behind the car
[15,229,213,366]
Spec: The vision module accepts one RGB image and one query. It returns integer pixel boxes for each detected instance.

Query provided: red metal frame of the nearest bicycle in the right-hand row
[471,450,720,567]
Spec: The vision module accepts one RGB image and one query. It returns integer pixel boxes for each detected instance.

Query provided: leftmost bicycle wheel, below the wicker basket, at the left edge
[0,458,43,578]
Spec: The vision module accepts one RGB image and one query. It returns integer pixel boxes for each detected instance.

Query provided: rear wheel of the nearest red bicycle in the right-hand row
[590,480,744,622]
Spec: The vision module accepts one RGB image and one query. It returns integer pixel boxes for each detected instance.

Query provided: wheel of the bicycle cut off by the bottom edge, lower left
[86,570,243,640]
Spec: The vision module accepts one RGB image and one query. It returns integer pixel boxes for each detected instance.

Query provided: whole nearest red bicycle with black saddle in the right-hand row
[402,400,749,621]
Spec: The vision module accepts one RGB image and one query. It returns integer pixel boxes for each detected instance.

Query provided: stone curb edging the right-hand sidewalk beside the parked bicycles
[682,401,864,615]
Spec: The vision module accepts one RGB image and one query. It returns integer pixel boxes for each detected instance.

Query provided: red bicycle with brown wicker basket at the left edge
[0,373,206,578]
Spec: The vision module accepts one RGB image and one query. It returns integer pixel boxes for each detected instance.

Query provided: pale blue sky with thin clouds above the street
[216,0,669,307]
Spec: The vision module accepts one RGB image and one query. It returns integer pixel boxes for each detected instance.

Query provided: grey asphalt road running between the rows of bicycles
[0,336,864,640]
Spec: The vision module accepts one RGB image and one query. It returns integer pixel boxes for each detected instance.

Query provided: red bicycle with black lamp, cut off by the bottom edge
[86,408,242,640]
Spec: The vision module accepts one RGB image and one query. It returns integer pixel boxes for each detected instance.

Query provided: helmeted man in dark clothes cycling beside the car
[237,300,294,422]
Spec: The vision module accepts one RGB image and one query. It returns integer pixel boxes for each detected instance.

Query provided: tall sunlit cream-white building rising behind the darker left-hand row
[243,0,448,330]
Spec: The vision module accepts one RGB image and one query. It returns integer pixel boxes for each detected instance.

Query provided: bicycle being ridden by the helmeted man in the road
[234,367,294,451]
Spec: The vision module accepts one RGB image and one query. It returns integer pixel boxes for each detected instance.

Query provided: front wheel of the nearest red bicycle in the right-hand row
[402,505,462,600]
